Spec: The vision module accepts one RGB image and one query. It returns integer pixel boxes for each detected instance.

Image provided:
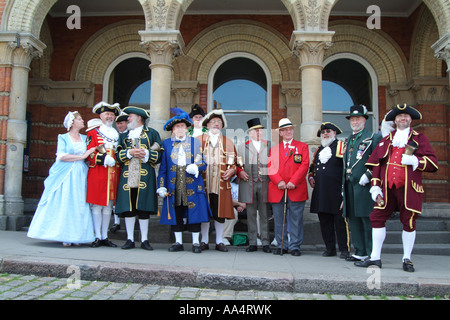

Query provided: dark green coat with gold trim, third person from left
[115,126,164,214]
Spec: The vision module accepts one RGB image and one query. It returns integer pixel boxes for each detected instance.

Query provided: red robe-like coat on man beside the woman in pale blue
[86,128,120,206]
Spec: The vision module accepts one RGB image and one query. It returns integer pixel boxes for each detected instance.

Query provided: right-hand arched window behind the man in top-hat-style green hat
[322,54,378,139]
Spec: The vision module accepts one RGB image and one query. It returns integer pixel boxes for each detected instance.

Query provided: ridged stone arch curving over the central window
[181,20,298,84]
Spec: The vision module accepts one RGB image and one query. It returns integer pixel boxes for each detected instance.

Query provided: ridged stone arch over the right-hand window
[324,20,409,86]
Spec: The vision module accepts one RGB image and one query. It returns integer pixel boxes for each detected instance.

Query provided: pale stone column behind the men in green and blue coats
[139,31,183,139]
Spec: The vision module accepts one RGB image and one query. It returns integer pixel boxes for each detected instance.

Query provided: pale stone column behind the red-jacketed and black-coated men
[291,31,334,145]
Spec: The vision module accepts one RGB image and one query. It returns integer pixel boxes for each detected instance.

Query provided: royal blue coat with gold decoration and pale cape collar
[158,136,212,225]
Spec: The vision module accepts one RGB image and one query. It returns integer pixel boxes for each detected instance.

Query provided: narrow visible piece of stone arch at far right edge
[410,6,443,78]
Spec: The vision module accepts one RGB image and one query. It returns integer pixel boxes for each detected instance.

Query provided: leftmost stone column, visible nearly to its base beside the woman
[0,34,45,225]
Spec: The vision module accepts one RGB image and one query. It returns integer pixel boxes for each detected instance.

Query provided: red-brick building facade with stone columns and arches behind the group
[0,0,450,230]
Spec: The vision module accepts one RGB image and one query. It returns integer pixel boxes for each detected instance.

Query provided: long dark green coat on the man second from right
[342,129,381,218]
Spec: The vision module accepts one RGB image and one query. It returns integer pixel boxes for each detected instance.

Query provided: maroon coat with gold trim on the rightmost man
[366,129,438,213]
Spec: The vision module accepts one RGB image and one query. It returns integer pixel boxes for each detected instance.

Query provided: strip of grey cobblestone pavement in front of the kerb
[0,274,449,301]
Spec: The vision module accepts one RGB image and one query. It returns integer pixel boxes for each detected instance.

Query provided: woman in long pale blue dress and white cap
[27,111,95,246]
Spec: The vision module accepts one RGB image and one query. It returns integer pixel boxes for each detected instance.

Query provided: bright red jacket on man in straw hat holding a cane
[268,140,309,203]
